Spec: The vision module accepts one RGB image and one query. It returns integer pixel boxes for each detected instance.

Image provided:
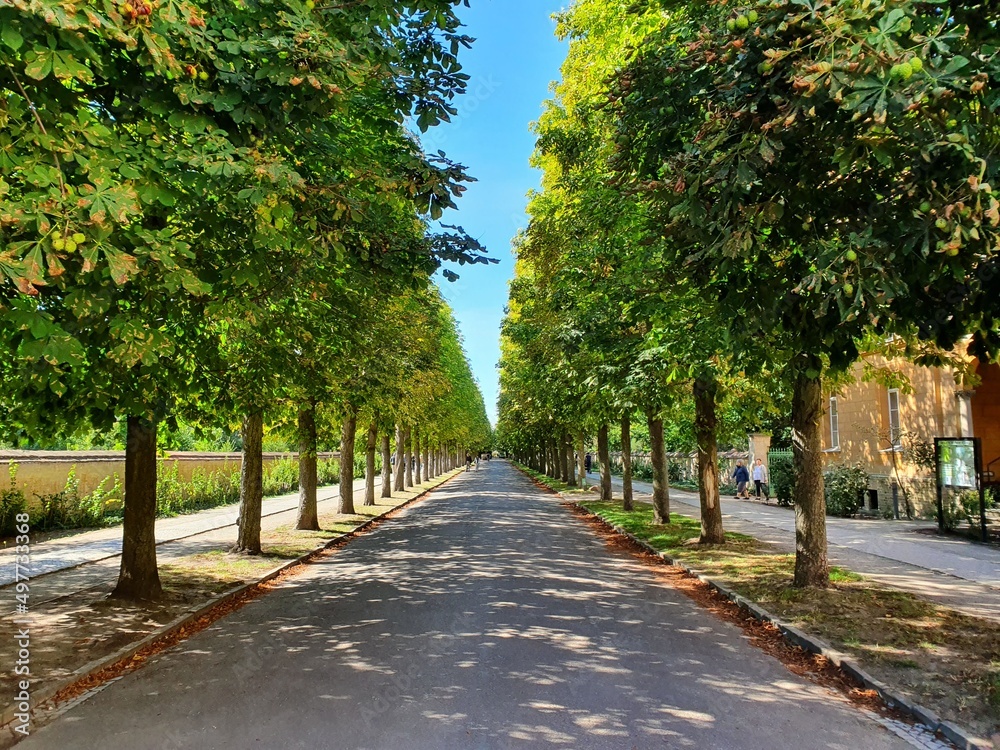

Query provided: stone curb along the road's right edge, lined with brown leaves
[516,468,996,750]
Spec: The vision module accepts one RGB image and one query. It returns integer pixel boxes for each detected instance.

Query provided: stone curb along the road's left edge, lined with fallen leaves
[0,471,459,742]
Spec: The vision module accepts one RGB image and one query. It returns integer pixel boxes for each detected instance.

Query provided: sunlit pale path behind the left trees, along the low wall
[0,477,382,586]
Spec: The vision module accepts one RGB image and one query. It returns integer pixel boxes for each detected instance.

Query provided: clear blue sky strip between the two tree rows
[432,0,568,422]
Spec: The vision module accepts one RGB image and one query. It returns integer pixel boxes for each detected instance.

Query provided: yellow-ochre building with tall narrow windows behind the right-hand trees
[823,357,1000,517]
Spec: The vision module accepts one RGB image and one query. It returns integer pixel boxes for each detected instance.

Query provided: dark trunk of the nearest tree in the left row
[111,417,163,601]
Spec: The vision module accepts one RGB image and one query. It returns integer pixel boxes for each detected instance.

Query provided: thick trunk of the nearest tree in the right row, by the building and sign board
[792,362,830,586]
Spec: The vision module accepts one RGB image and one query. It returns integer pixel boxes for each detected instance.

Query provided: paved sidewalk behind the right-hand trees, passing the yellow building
[587,474,1000,621]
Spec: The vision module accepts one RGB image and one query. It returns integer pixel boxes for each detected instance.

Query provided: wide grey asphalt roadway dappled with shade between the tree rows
[18,461,910,750]
